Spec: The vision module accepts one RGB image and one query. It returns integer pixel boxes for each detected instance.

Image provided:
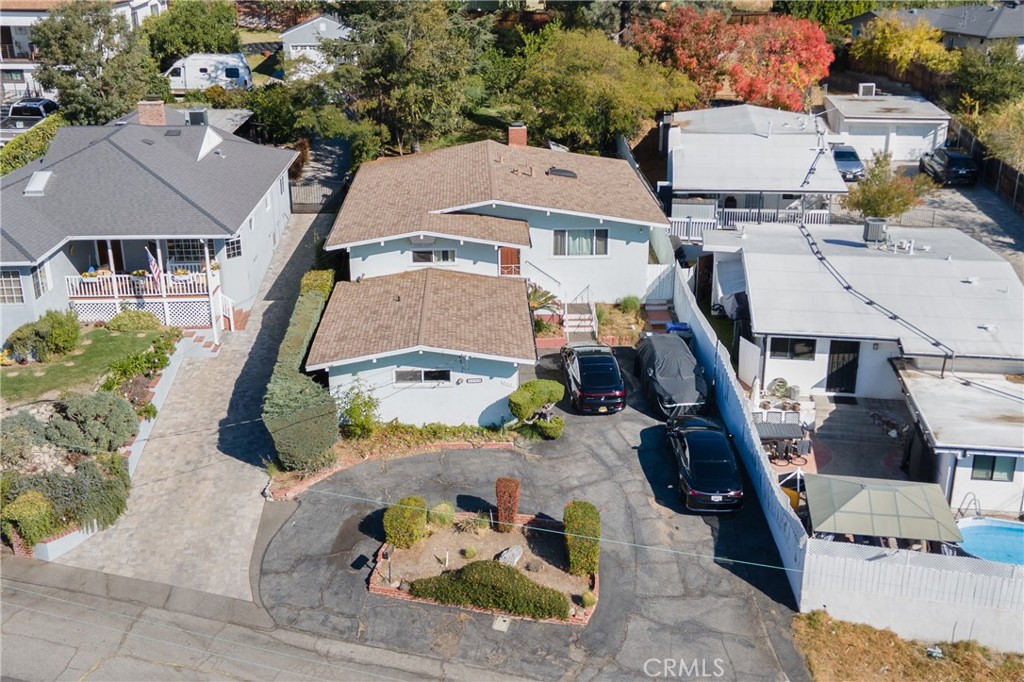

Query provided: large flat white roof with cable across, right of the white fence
[705,224,1024,358]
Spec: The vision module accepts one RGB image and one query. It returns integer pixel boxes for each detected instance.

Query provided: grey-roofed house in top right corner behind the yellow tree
[843,0,1024,58]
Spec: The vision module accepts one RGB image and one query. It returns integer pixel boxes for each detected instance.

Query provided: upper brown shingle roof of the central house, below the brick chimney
[327,140,667,248]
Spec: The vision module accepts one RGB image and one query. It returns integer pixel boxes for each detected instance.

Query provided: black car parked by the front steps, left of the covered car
[561,343,626,414]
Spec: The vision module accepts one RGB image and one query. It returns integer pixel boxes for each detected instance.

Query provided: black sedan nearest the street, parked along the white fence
[668,417,743,512]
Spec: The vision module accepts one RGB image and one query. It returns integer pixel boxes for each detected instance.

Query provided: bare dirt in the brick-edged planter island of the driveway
[391,518,590,604]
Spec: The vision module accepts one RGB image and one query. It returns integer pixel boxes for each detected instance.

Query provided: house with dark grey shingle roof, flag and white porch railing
[0,101,295,338]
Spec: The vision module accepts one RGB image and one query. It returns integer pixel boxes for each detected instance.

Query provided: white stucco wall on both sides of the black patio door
[763,337,903,400]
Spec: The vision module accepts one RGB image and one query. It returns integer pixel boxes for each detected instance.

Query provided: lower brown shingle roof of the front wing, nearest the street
[306,267,536,369]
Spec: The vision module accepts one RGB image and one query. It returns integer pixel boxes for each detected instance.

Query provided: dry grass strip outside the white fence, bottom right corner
[793,611,1024,682]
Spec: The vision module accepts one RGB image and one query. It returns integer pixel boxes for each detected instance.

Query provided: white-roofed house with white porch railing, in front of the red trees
[663,100,847,240]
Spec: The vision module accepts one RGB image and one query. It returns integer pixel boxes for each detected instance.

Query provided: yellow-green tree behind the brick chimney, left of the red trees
[513,31,696,153]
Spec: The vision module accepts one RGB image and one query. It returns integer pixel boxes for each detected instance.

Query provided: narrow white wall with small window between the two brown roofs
[349,238,498,280]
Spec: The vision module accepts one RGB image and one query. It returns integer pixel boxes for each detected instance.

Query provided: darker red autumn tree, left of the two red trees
[630,5,736,104]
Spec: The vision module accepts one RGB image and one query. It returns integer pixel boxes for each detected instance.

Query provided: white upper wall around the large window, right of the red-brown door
[473,206,649,302]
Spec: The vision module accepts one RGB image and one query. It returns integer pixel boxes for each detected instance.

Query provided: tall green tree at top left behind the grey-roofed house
[32,0,167,125]
